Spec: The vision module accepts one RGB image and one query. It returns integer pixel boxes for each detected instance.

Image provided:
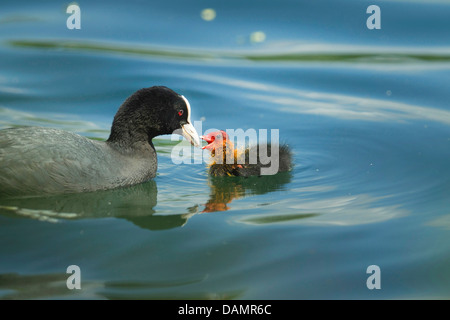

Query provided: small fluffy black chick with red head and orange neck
[201,130,292,177]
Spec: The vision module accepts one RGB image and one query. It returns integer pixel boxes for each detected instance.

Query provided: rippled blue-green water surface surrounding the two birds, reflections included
[0,0,450,299]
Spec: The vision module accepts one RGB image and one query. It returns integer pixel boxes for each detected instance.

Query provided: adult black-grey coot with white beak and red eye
[0,86,200,196]
